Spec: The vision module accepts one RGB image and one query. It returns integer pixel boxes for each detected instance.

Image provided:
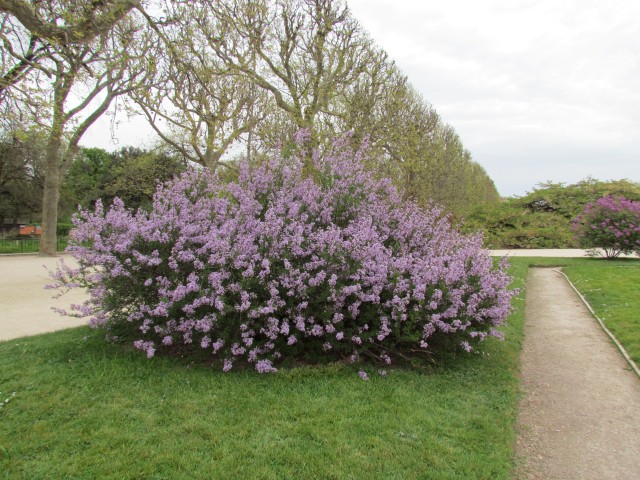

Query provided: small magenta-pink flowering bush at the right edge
[573,196,640,258]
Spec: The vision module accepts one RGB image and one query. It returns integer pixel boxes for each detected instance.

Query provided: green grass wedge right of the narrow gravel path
[564,260,640,365]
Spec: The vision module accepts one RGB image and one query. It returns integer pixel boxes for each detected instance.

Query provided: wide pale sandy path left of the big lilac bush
[0,255,87,340]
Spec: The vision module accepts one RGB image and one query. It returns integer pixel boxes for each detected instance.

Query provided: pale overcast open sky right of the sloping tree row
[83,0,640,196]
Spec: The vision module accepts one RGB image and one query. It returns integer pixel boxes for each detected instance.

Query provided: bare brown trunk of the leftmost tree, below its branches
[40,138,61,257]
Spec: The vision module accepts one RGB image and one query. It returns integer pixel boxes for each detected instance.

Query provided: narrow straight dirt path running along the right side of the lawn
[516,268,640,480]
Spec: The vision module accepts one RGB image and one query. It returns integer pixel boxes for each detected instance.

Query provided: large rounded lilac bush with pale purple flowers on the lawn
[55,133,514,372]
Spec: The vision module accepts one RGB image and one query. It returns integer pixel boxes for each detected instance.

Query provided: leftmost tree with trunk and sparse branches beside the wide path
[3,1,150,255]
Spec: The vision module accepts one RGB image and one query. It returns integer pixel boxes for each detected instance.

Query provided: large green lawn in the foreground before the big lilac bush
[0,263,527,479]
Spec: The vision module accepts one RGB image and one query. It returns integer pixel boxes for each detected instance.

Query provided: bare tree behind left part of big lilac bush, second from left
[131,2,268,170]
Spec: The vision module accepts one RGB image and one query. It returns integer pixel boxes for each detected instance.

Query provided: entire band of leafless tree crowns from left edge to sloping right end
[0,0,497,255]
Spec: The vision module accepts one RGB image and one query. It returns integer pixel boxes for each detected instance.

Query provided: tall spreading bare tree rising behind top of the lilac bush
[197,0,370,153]
